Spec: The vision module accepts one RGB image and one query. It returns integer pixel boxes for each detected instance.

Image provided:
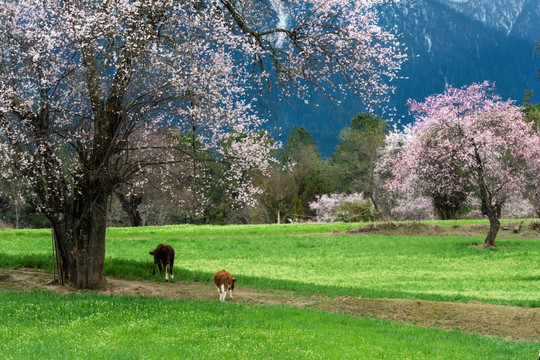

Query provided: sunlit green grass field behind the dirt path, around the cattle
[0,219,540,307]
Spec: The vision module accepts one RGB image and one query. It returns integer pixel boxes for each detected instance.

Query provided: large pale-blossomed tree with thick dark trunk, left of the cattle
[0,0,404,288]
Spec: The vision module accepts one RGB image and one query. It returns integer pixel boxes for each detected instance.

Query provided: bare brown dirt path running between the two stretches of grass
[0,269,540,342]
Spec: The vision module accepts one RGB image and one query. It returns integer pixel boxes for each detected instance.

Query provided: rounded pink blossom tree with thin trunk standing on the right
[392,82,536,246]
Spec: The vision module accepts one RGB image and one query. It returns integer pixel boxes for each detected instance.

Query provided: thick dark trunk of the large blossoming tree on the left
[53,196,107,289]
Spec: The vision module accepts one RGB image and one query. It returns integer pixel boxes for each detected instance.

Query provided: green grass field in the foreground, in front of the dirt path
[0,291,538,360]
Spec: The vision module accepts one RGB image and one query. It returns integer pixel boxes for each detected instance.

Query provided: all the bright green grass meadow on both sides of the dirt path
[0,222,540,359]
